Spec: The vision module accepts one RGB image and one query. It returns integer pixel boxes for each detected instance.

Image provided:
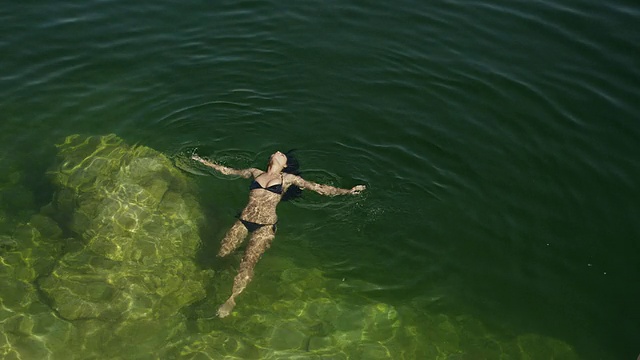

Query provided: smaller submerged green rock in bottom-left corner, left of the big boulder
[0,215,73,359]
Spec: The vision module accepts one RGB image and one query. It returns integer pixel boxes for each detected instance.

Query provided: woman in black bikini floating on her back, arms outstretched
[192,151,365,318]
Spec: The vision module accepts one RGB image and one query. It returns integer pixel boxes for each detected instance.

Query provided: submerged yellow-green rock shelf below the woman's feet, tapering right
[174,256,578,360]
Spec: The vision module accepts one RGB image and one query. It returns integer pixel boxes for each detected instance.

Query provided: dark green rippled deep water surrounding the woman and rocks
[0,0,640,359]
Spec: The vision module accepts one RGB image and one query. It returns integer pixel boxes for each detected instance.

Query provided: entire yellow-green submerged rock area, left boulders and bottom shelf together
[0,135,578,360]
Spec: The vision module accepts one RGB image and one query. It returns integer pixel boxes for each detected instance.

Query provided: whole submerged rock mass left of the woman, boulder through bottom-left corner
[0,135,210,359]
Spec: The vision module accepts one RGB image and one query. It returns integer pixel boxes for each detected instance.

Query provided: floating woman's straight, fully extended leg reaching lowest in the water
[218,225,275,318]
